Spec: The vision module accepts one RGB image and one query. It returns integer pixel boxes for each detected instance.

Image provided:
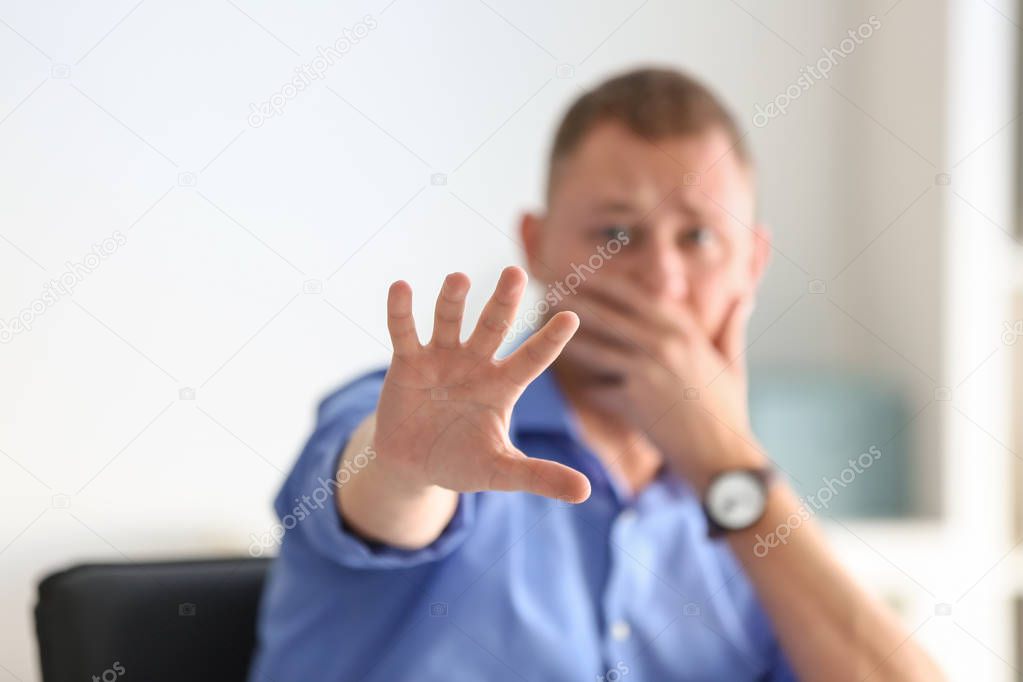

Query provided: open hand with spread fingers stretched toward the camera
[373,267,589,502]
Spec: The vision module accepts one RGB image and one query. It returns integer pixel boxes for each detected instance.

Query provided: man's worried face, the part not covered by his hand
[522,123,769,336]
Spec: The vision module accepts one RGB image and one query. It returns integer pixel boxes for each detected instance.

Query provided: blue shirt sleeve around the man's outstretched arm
[274,369,476,570]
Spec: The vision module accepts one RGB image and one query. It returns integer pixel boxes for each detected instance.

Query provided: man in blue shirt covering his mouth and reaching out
[252,70,940,682]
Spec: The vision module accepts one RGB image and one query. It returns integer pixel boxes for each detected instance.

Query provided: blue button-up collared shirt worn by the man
[250,370,796,682]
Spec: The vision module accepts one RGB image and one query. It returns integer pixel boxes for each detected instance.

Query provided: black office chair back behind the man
[36,558,269,682]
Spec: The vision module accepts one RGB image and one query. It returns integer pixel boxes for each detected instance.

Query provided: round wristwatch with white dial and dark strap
[703,467,773,538]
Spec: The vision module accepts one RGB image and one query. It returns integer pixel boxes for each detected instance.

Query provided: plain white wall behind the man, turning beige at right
[0,0,1008,680]
